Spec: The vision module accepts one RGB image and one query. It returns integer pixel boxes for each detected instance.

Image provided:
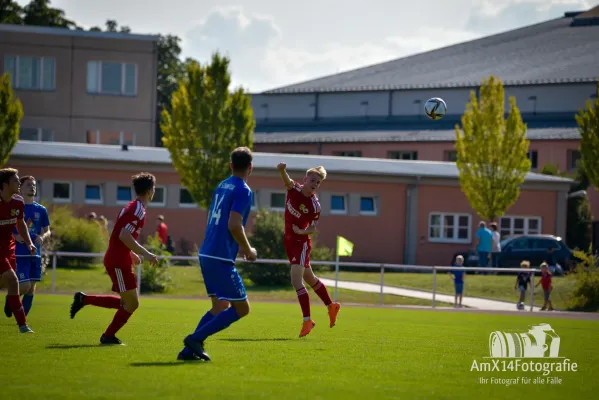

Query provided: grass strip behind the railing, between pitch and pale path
[31,267,450,307]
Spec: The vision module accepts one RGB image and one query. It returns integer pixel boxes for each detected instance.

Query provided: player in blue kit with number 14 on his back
[182,147,257,361]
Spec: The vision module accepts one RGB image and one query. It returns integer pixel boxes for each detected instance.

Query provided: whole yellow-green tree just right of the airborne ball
[455,76,531,221]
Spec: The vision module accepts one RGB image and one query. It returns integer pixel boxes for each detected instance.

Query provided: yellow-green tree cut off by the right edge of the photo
[576,83,599,188]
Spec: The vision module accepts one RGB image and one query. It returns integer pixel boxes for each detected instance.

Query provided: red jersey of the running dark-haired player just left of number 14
[104,200,146,268]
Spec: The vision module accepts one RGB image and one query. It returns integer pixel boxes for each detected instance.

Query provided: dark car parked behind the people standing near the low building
[452,235,573,275]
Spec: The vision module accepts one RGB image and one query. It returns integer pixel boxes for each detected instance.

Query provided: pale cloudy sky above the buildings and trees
[18,0,599,92]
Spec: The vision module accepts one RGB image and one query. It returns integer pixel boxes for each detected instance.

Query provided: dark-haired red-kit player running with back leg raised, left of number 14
[71,172,158,344]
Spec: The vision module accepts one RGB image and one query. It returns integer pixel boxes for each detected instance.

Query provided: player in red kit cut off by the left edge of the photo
[0,168,37,333]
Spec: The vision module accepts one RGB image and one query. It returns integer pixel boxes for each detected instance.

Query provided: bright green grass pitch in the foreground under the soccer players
[0,294,599,400]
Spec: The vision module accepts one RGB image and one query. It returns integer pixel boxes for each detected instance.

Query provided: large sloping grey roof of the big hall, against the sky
[263,11,599,94]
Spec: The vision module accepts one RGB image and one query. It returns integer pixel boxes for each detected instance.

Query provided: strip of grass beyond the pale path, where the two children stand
[320,271,574,310]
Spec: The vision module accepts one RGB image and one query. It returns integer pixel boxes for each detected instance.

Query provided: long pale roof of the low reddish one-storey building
[11,140,571,184]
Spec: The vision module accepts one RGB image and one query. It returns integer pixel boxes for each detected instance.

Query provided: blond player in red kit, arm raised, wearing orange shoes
[277,162,341,337]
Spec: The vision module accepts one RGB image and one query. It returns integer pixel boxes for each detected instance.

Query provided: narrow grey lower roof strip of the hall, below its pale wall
[254,128,580,143]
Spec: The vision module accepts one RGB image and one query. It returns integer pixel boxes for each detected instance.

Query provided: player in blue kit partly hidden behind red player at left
[4,176,50,318]
